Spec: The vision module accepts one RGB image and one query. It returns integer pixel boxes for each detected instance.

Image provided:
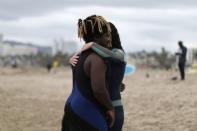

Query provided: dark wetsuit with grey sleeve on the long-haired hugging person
[92,43,126,131]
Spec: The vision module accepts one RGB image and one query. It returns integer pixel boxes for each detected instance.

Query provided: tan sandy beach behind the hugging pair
[0,68,197,131]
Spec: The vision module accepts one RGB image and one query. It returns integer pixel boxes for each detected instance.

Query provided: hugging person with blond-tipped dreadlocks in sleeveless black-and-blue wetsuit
[62,15,115,131]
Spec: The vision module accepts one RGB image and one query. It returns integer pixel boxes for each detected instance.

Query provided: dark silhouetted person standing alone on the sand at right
[176,41,187,80]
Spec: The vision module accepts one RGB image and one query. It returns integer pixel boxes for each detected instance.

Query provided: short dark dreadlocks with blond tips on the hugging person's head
[78,15,111,47]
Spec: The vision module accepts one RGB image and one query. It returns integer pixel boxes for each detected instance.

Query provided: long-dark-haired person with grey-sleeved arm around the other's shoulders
[69,23,126,131]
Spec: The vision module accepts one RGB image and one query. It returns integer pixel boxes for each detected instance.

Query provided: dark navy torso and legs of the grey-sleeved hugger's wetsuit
[106,58,126,131]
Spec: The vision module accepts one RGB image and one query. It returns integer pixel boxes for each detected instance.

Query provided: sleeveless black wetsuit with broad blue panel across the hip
[62,50,108,131]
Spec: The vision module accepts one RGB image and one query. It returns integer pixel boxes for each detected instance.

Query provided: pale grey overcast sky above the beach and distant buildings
[0,0,197,51]
